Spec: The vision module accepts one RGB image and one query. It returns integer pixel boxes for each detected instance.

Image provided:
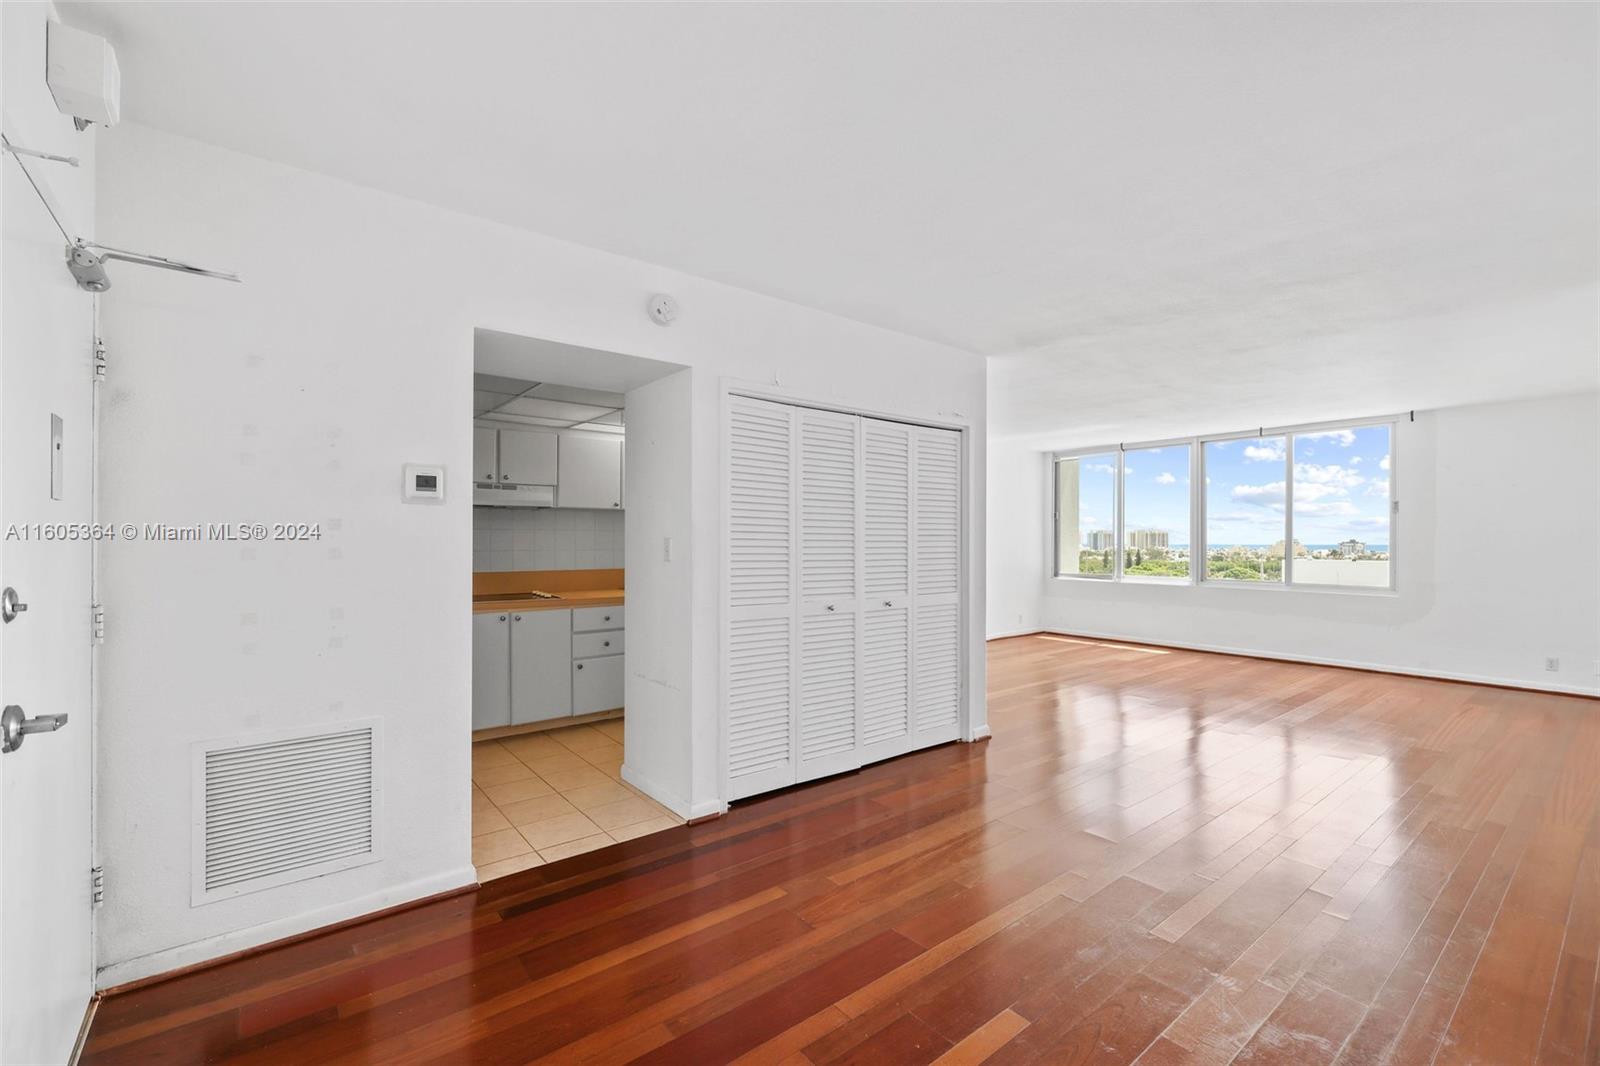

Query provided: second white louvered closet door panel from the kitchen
[795,408,861,781]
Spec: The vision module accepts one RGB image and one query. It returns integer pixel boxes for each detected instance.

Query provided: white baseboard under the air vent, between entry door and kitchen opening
[94,866,478,997]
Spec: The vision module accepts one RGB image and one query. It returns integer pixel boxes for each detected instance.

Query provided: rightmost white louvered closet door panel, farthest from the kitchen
[910,427,963,747]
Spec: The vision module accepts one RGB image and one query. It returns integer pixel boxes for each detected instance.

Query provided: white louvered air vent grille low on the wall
[194,720,379,903]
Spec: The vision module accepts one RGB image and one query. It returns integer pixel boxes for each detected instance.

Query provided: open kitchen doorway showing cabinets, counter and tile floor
[470,330,690,882]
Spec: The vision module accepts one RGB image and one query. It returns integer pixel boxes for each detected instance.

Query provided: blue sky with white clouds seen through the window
[1078,426,1389,546]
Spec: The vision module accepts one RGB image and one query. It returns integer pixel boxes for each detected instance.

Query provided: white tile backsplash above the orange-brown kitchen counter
[472,507,622,573]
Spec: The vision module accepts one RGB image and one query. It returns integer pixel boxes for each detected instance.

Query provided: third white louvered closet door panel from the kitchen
[861,418,912,763]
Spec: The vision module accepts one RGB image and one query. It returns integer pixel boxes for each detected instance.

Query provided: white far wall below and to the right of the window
[989,392,1600,693]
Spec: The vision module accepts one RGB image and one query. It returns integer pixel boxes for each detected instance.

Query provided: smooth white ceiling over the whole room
[62,3,1600,439]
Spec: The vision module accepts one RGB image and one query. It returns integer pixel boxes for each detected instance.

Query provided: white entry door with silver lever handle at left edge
[0,27,94,1063]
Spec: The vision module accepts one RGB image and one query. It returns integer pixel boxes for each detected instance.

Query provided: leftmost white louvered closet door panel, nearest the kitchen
[725,397,798,799]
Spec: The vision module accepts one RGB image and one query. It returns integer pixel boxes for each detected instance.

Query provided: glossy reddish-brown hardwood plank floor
[83,637,1600,1066]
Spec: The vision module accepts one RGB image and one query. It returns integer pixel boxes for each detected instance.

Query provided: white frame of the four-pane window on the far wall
[1050,415,1414,595]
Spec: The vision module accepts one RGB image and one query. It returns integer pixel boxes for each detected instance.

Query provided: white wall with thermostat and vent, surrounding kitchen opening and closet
[98,123,984,984]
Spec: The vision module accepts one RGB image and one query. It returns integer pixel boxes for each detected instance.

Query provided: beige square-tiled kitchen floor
[472,719,683,882]
